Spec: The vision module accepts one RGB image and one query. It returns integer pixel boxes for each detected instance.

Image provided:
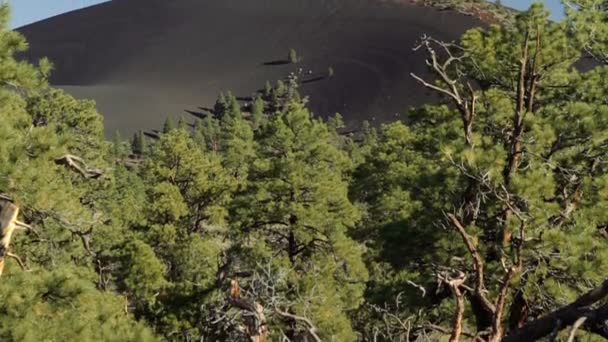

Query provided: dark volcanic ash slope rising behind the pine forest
[19,0,480,133]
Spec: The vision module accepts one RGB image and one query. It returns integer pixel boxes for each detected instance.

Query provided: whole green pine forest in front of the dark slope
[0,0,608,342]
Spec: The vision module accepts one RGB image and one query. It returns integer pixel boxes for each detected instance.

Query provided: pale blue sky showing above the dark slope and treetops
[8,0,562,28]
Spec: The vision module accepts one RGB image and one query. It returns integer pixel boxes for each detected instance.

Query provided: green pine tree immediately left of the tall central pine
[126,129,236,339]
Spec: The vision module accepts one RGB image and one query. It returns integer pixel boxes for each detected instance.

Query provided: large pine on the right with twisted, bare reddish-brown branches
[354,4,608,341]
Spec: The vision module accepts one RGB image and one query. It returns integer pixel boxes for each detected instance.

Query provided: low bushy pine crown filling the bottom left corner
[0,269,158,341]
